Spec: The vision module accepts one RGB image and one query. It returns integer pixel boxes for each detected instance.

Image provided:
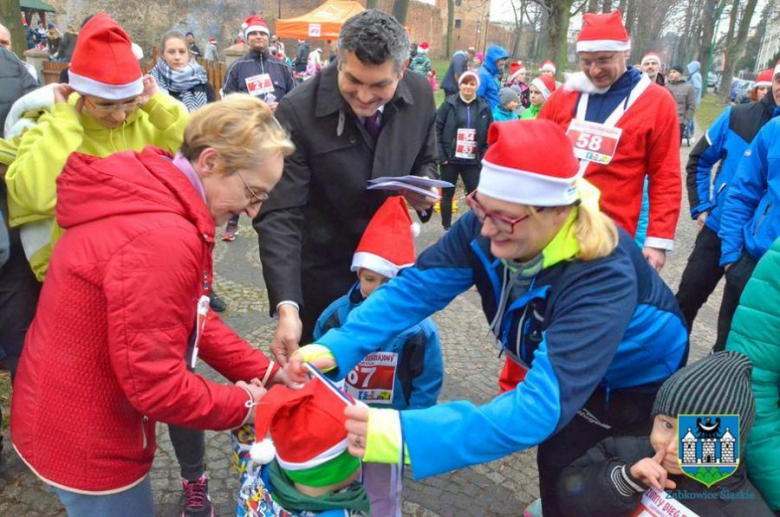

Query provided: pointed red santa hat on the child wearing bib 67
[352,196,418,278]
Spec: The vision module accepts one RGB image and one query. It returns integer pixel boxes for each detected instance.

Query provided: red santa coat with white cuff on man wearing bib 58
[539,79,682,250]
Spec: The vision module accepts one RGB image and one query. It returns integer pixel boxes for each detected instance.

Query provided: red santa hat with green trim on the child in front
[249,370,360,486]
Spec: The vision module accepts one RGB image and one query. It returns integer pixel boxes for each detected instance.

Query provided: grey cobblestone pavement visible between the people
[0,135,721,517]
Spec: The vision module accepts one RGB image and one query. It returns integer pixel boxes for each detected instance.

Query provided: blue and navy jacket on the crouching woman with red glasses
[318,213,688,478]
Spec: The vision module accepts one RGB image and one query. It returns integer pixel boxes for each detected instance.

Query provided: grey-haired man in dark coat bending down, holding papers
[254,10,437,363]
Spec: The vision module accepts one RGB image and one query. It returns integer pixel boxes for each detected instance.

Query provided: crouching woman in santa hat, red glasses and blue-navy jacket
[290,120,688,517]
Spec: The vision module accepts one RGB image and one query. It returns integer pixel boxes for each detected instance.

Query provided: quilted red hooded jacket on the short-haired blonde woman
[11,147,275,493]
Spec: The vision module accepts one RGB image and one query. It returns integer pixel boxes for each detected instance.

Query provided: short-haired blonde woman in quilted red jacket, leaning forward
[11,95,293,517]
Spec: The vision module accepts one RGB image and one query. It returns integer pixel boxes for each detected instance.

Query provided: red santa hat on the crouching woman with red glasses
[477,119,581,206]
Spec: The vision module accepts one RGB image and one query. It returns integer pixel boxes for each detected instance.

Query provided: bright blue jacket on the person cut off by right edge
[718,117,780,266]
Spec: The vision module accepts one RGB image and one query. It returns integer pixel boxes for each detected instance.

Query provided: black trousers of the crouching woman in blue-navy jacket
[536,385,660,517]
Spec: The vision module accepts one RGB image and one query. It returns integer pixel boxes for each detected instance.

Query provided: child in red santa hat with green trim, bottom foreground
[236,370,372,517]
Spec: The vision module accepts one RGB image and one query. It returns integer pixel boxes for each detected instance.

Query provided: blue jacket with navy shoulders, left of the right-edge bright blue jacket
[685,95,780,233]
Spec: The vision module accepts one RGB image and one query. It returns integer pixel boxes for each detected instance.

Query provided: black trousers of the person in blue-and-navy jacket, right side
[675,225,723,333]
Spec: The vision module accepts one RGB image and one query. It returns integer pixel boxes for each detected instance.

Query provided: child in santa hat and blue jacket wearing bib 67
[314,196,444,517]
